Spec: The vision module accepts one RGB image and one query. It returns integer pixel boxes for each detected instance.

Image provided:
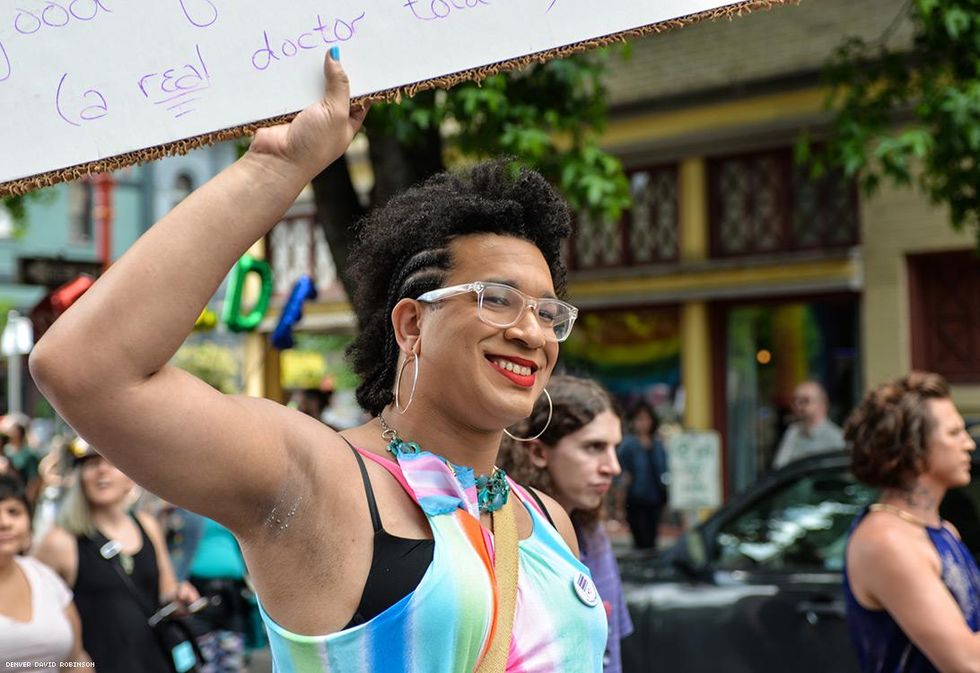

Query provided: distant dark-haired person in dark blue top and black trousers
[616,402,668,549]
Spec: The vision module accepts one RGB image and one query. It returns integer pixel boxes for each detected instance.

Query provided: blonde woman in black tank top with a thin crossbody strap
[37,439,198,673]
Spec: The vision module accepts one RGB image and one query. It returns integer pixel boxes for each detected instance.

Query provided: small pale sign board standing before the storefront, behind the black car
[667,432,721,510]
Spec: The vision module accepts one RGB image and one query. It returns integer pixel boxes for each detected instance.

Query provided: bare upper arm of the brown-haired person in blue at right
[848,526,980,673]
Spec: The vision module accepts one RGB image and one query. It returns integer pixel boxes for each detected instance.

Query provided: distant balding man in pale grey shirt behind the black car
[772,381,844,469]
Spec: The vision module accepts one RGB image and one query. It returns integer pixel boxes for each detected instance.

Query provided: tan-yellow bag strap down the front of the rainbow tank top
[476,492,517,673]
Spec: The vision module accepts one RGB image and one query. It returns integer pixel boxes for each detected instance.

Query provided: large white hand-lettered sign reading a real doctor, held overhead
[0,0,785,196]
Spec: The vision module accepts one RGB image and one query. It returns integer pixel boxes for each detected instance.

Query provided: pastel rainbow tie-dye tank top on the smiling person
[262,444,607,673]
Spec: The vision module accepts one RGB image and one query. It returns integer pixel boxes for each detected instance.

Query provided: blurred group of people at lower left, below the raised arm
[0,414,261,673]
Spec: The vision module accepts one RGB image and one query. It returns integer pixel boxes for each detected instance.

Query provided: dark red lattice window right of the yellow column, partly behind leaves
[708,148,859,257]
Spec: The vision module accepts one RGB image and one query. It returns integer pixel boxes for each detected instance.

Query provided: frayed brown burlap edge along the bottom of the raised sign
[0,0,798,197]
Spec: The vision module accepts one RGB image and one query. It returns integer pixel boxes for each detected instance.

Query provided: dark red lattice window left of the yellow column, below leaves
[571,165,678,269]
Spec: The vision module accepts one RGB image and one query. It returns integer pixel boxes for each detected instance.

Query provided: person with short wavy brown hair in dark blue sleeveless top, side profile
[844,372,980,673]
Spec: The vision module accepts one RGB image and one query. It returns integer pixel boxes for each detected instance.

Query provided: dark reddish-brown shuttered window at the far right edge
[908,251,980,383]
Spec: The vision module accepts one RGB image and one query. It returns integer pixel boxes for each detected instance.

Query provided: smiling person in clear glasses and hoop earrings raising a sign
[31,52,606,673]
